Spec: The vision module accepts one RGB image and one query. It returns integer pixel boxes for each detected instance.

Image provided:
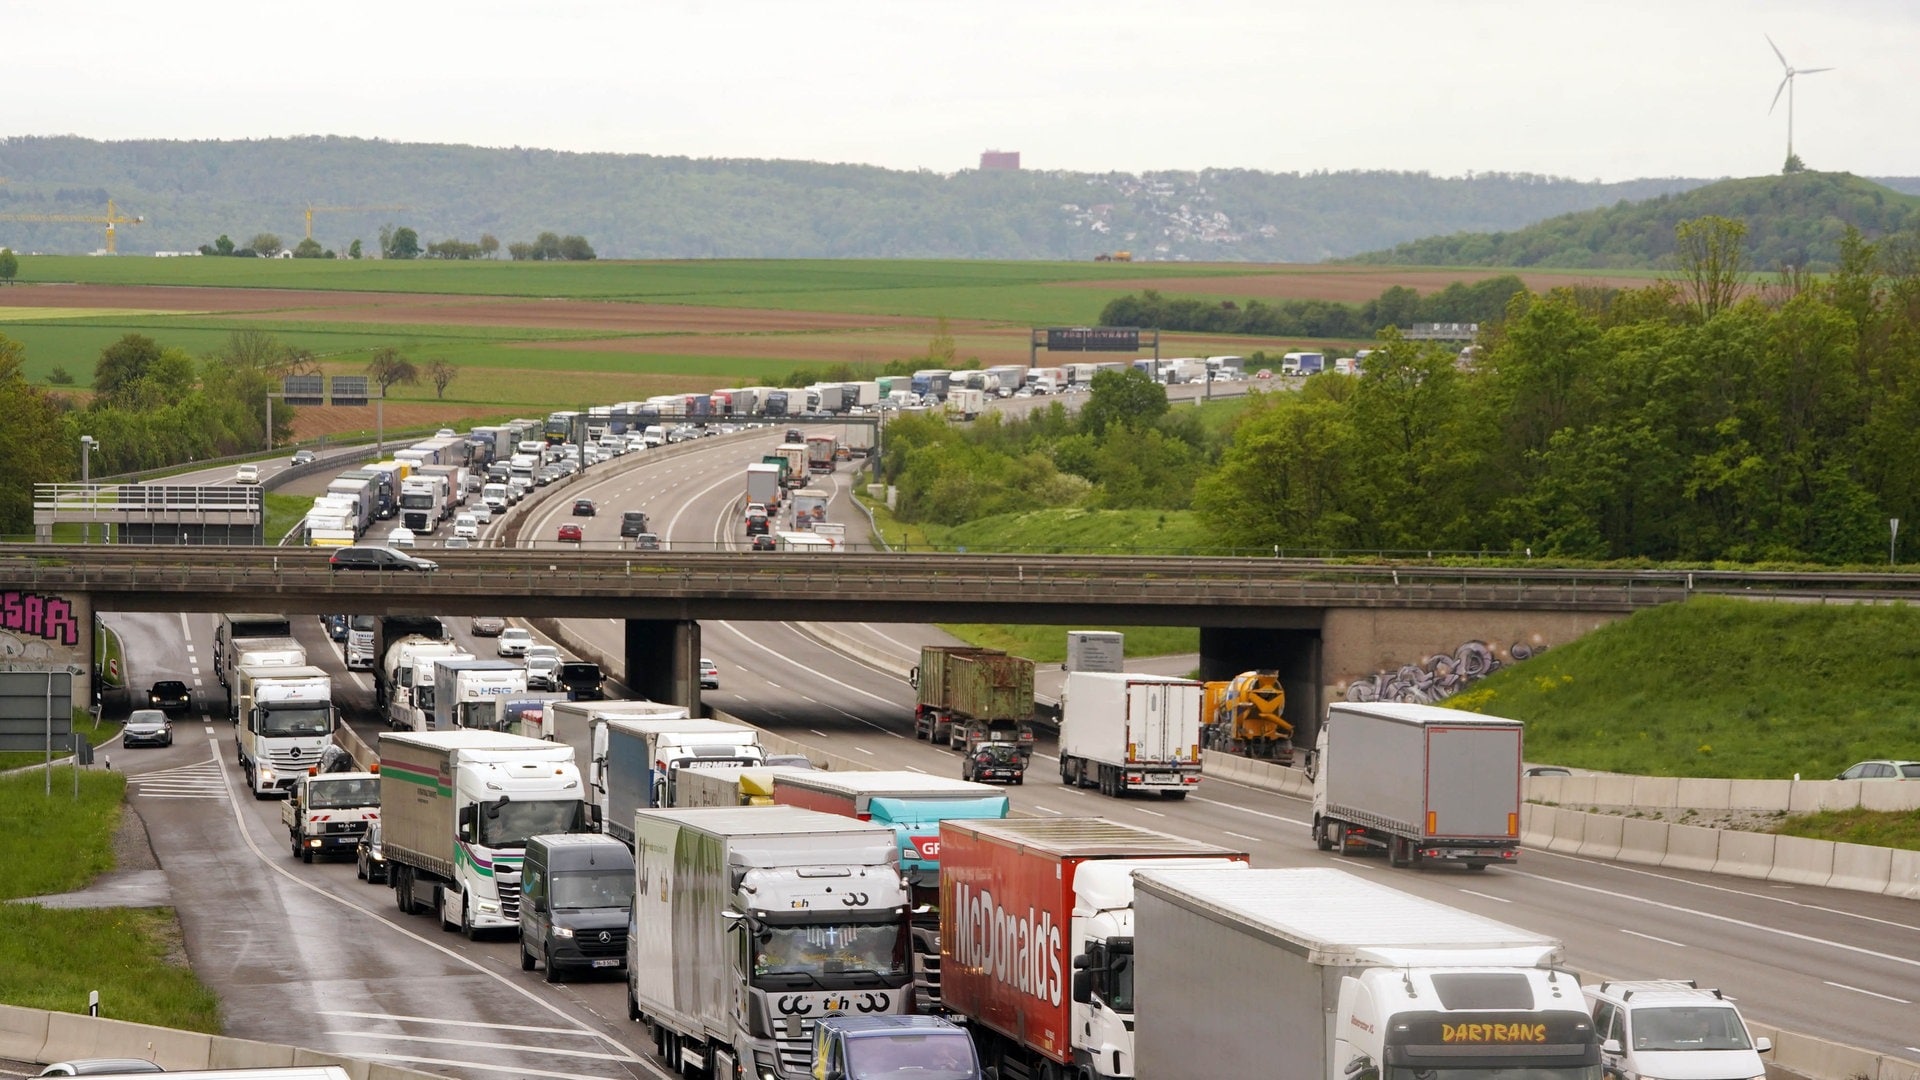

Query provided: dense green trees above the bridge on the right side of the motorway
[887,219,1920,565]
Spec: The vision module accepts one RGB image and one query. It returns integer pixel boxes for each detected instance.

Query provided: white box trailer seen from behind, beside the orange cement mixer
[1060,671,1206,799]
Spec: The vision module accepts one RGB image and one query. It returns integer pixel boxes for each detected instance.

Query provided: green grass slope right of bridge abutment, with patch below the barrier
[1448,598,1920,847]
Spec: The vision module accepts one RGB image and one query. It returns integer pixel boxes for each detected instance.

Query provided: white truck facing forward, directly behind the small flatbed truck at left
[232,665,336,799]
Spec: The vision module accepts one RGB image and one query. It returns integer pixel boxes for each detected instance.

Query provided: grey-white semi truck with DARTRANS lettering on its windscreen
[1133,867,1599,1080]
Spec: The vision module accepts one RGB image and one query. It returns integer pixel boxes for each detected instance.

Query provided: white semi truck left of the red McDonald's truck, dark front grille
[626,807,912,1080]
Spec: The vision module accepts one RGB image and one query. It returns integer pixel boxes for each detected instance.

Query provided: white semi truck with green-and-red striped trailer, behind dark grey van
[380,730,593,938]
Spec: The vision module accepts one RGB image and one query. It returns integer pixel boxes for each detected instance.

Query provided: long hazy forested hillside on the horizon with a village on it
[0,136,1705,261]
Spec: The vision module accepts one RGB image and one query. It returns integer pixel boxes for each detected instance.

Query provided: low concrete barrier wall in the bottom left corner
[0,1005,439,1080]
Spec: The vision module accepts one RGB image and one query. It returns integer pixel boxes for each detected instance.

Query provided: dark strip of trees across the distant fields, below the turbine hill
[1100,275,1526,338]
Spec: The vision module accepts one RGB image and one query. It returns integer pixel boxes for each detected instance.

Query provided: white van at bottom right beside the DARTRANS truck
[1580,978,1774,1080]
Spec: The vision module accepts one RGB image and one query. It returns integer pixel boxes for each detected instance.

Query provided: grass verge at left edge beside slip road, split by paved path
[0,769,221,1032]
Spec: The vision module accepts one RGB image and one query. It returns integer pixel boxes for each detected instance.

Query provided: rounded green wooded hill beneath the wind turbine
[1354,173,1920,271]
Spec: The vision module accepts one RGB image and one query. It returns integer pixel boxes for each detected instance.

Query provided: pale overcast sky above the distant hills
[0,0,1920,181]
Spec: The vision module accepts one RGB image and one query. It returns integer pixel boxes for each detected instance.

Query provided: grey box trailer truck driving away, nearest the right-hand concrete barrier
[1311,701,1524,871]
